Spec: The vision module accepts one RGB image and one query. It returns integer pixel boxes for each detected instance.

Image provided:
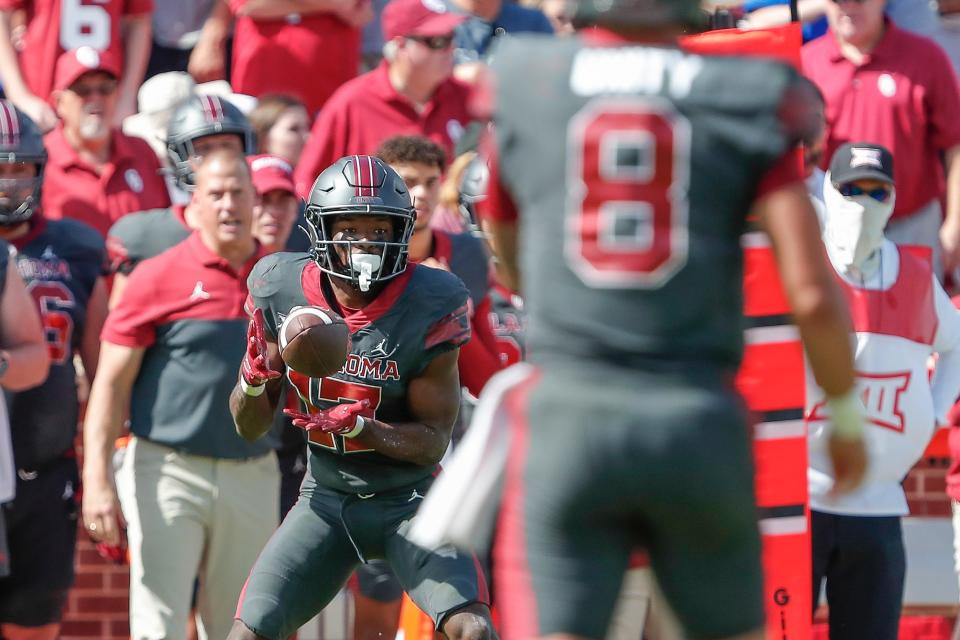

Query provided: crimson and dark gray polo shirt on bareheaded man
[101,233,276,458]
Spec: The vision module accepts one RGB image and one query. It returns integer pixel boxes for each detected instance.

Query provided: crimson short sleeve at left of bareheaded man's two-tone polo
[100,269,161,348]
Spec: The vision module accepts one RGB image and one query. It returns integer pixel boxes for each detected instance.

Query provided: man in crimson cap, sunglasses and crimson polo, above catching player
[294,0,470,197]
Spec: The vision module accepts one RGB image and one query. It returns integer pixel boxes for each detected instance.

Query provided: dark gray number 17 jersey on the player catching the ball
[249,253,470,493]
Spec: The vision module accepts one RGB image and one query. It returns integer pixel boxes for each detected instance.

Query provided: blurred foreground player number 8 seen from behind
[478,0,866,640]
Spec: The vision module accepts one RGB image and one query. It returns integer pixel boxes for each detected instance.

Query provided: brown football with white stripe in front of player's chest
[280,307,350,378]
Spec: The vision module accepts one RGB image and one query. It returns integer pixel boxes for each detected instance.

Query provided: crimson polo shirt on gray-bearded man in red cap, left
[41,124,170,237]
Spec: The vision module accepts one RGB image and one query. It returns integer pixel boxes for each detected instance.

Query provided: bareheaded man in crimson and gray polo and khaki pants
[83,150,280,638]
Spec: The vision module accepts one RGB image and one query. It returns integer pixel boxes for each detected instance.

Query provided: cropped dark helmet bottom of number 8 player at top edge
[573,0,707,29]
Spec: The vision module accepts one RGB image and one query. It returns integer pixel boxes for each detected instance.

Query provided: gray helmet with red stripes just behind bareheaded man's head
[167,95,257,191]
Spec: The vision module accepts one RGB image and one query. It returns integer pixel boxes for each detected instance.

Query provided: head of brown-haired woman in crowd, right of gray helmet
[250,94,310,167]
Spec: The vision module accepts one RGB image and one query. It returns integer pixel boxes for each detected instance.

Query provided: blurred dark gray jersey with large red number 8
[483,35,805,368]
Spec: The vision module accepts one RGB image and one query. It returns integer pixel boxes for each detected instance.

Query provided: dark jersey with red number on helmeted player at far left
[6,217,105,469]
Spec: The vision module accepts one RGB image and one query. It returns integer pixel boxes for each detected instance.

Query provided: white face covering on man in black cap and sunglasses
[823,175,896,276]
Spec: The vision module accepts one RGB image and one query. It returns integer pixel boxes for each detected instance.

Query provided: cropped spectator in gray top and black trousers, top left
[147,0,218,79]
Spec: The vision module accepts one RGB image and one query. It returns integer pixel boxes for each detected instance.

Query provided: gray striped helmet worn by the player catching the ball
[304,156,416,291]
